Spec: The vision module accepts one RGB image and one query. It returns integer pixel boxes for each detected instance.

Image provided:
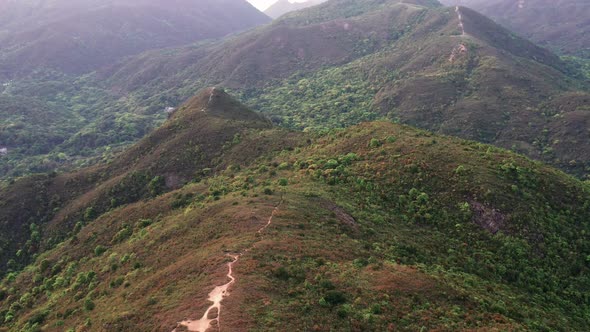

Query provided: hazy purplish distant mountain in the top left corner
[0,0,269,80]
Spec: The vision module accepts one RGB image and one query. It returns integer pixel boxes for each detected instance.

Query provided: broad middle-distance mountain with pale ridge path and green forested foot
[0,0,590,182]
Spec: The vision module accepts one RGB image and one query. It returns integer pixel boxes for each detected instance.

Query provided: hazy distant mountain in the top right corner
[443,0,590,58]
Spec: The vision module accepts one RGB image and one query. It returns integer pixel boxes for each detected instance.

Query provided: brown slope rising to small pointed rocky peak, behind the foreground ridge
[0,88,306,278]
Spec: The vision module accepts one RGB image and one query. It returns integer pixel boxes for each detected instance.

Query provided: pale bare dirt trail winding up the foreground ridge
[172,200,283,332]
